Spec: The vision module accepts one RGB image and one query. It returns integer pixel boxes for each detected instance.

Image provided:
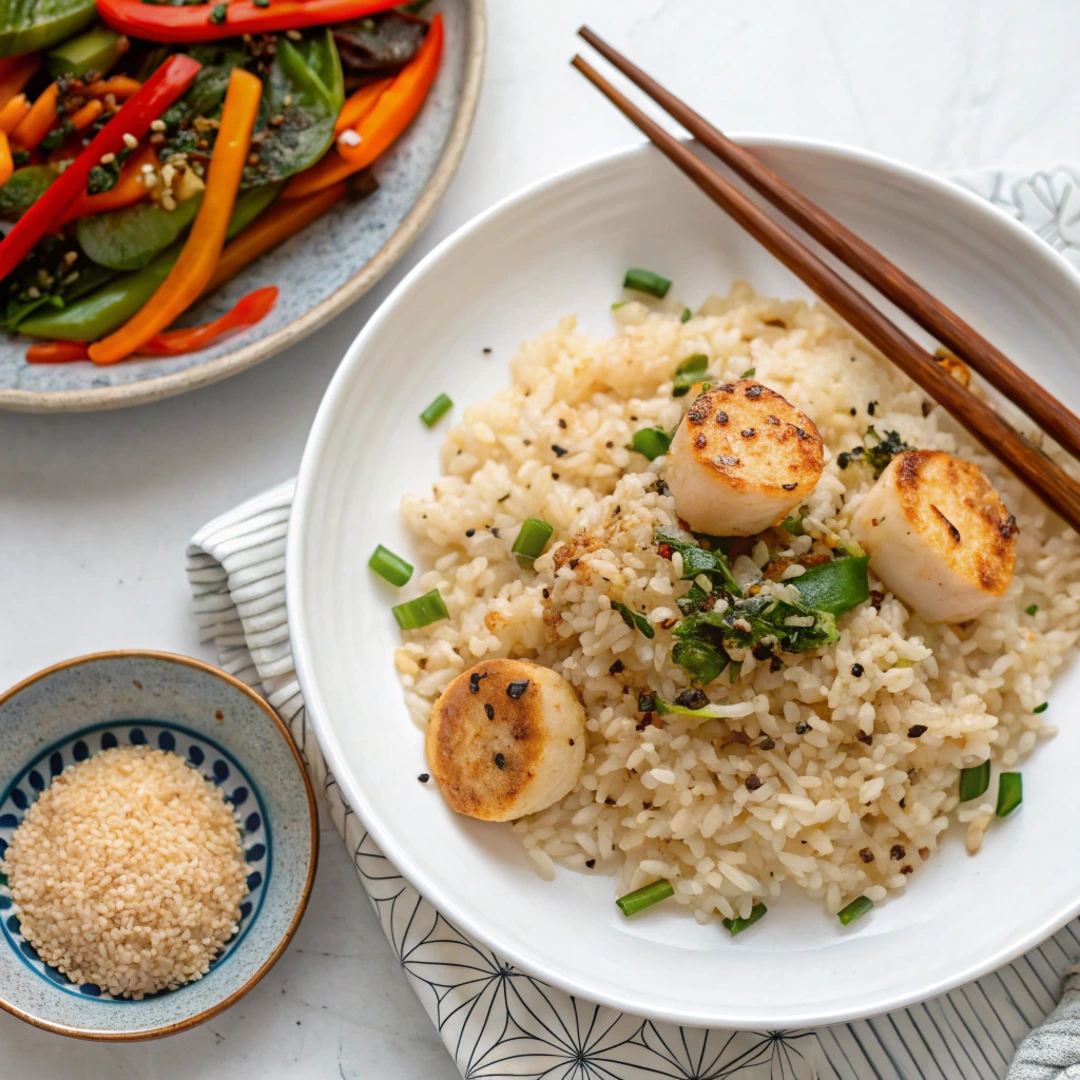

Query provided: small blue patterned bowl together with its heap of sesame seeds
[0,652,319,1040]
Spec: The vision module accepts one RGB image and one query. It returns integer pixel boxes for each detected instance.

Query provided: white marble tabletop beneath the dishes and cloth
[0,0,1080,1080]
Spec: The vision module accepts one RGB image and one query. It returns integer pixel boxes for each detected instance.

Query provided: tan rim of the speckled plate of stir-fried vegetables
[0,0,487,413]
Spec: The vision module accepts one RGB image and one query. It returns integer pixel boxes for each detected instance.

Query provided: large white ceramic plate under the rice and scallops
[286,137,1080,1028]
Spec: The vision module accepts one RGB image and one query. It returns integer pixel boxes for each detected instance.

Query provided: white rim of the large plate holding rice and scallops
[285,132,1080,1029]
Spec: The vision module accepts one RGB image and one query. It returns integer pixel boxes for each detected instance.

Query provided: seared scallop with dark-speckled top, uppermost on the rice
[666,379,824,537]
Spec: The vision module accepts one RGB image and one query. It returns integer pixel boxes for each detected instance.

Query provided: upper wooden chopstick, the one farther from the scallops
[578,26,1080,468]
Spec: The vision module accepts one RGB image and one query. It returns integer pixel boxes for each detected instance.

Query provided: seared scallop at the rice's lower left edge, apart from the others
[427,660,585,821]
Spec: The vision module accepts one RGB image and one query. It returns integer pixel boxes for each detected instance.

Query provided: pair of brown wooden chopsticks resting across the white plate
[572,27,1080,531]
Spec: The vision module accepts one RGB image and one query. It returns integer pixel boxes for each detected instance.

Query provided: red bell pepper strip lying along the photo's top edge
[97,0,402,44]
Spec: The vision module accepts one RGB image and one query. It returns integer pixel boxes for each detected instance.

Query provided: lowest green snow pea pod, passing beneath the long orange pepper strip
[18,184,282,341]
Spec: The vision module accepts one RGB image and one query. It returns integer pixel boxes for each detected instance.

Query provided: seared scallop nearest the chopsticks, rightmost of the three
[851,450,1020,622]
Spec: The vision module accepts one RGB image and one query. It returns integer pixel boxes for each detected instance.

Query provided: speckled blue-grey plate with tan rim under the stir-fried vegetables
[0,0,484,413]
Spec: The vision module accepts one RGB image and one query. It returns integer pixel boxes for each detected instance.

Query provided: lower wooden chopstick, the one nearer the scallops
[572,56,1080,531]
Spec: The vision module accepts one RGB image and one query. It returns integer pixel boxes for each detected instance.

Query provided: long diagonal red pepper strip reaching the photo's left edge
[0,51,202,281]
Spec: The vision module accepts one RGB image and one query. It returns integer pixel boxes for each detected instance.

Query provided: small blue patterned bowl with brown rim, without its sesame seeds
[0,652,319,1040]
